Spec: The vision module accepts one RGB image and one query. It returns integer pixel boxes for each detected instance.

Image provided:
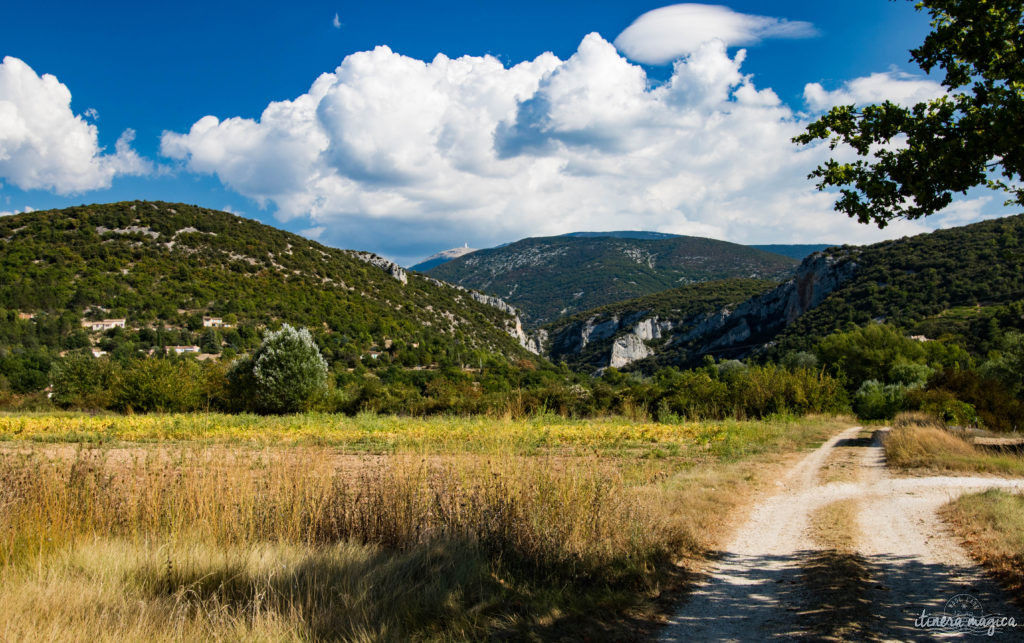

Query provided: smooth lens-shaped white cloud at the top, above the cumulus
[615,4,817,65]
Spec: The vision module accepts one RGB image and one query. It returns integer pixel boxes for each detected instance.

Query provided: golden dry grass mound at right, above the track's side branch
[885,414,1024,476]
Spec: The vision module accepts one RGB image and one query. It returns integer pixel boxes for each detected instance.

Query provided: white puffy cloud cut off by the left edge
[0,56,150,195]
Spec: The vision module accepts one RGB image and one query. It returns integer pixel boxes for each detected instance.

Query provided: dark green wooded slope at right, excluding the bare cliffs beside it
[778,215,1024,354]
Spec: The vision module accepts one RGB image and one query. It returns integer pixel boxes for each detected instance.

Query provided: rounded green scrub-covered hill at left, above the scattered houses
[0,202,540,372]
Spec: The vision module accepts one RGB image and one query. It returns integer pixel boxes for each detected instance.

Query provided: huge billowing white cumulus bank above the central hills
[162,34,991,259]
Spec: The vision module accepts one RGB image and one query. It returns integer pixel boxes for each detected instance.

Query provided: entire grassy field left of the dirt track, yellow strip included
[0,415,846,641]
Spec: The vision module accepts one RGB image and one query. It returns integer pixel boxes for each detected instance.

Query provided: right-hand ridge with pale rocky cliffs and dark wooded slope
[541,215,1024,373]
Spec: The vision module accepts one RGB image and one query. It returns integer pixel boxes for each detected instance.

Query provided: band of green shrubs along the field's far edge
[14,344,848,421]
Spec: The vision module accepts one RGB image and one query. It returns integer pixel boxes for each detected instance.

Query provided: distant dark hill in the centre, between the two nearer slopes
[419,235,799,328]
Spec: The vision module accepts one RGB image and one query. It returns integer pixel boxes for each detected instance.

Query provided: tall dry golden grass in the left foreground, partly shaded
[0,447,695,640]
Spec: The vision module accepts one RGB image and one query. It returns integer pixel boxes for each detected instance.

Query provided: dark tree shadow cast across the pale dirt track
[663,551,1024,641]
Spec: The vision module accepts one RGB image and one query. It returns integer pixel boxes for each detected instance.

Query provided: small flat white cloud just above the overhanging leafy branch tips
[804,72,945,111]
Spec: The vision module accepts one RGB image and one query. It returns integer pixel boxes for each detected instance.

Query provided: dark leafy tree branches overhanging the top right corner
[794,0,1024,227]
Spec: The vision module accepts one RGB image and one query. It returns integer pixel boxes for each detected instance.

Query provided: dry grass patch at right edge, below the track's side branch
[941,489,1024,605]
